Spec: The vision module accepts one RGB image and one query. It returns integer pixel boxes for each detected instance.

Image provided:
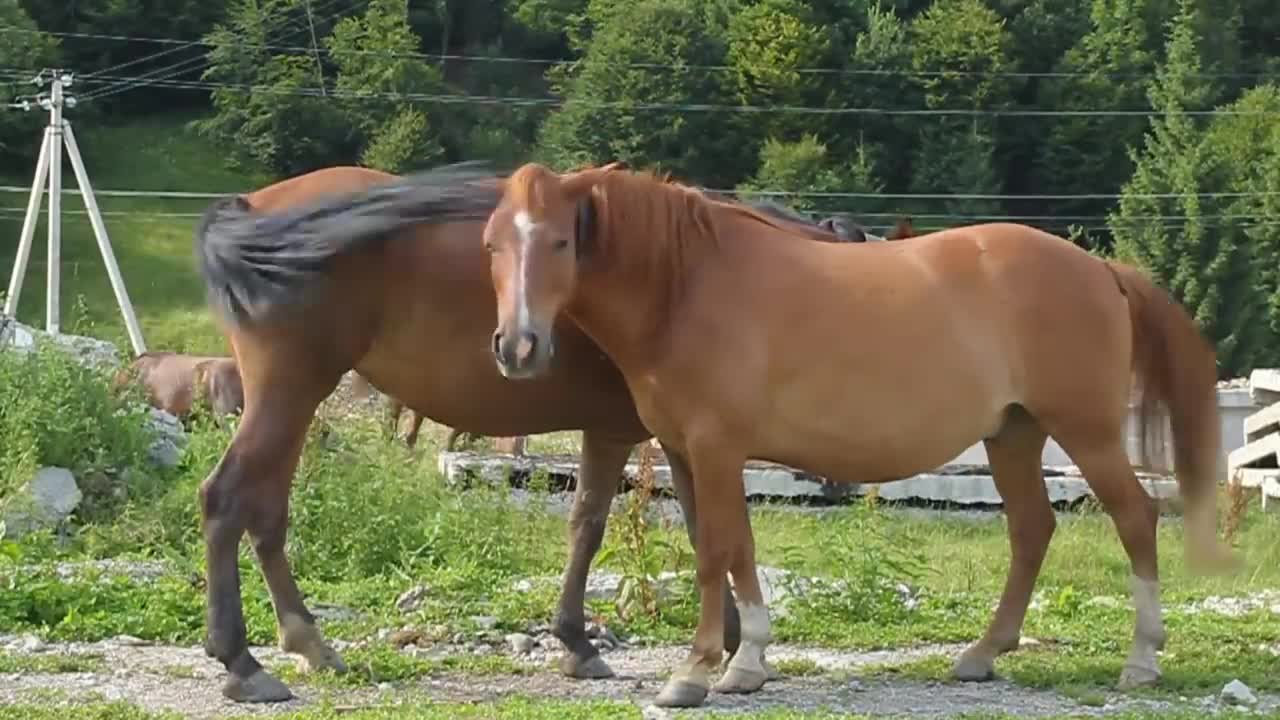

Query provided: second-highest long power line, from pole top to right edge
[35,71,1280,118]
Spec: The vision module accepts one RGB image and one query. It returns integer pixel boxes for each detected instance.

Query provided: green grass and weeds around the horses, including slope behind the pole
[0,114,1280,720]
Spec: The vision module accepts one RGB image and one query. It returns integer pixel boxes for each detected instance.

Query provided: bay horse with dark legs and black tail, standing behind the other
[186,165,837,702]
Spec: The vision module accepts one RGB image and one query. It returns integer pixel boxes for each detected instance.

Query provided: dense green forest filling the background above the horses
[0,0,1280,372]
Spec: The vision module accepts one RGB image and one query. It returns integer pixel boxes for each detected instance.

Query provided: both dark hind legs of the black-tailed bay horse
[200,361,342,702]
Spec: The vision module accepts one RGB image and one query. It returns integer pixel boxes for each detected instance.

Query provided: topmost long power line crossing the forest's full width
[0,28,1280,79]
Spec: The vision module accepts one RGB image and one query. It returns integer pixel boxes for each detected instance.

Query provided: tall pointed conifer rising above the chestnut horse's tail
[1110,0,1263,377]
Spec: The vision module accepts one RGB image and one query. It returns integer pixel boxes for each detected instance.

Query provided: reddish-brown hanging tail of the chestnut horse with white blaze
[1107,261,1239,573]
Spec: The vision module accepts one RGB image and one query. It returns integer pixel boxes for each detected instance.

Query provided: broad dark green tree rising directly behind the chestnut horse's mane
[539,0,758,187]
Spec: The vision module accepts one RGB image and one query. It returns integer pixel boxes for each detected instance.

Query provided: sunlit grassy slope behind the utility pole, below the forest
[0,110,270,352]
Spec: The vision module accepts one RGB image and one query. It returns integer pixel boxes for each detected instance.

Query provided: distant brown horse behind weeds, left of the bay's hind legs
[114,351,244,419]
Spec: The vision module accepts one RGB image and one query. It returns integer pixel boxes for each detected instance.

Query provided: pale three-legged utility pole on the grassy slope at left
[4,69,146,355]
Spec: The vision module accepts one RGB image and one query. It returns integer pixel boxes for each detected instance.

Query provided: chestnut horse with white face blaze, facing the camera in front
[483,163,1236,706]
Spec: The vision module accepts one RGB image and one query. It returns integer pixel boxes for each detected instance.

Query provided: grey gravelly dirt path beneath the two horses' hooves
[0,637,1264,720]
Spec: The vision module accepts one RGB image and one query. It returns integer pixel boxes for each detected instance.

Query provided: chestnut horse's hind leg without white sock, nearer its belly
[952,407,1056,680]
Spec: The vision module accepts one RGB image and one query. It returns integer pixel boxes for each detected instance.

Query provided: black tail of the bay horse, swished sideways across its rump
[195,163,499,324]
